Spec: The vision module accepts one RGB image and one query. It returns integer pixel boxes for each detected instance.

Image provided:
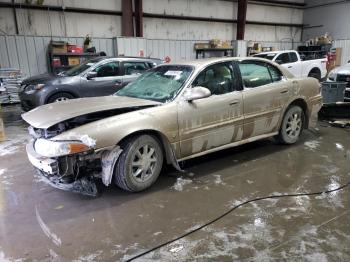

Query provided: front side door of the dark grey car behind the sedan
[81,61,123,96]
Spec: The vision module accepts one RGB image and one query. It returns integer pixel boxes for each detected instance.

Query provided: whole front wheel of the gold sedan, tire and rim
[114,135,164,192]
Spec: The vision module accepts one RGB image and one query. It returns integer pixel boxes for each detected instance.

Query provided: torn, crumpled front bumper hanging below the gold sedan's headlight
[26,141,98,196]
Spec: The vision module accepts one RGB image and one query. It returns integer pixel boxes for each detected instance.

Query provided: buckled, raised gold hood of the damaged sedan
[22,96,161,129]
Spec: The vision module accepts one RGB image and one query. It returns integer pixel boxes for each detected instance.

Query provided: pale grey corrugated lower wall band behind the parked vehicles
[4,36,342,76]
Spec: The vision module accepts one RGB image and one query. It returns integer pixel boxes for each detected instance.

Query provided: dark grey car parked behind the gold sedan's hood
[19,57,162,111]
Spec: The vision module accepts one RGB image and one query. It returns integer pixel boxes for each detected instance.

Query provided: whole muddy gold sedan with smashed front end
[22,58,321,195]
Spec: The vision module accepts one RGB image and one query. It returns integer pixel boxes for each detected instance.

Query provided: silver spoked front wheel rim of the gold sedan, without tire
[131,145,157,182]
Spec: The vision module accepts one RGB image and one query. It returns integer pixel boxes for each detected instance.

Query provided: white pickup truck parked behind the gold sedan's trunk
[254,50,327,80]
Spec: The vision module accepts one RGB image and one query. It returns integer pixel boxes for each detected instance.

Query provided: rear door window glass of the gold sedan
[239,61,272,88]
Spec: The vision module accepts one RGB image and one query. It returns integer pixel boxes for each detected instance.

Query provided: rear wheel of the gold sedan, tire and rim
[277,106,305,145]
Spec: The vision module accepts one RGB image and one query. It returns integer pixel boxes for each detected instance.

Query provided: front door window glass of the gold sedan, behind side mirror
[192,64,234,95]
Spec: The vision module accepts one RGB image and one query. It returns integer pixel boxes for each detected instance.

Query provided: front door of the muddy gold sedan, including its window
[179,62,243,159]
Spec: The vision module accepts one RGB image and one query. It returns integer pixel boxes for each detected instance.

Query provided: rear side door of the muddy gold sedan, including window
[239,60,291,139]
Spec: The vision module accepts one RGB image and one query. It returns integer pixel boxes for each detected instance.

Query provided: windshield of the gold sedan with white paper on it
[115,65,193,102]
